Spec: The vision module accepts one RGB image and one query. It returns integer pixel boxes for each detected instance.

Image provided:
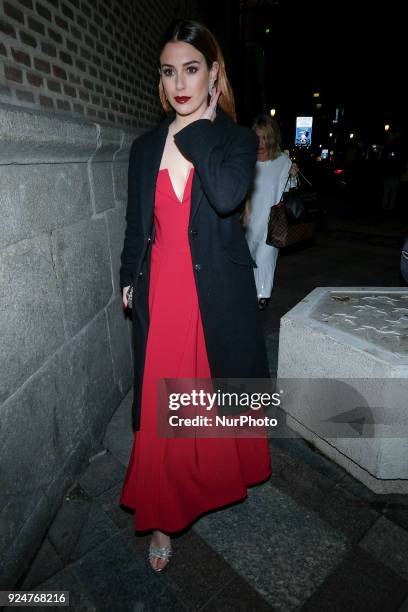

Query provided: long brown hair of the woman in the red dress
[158,19,237,121]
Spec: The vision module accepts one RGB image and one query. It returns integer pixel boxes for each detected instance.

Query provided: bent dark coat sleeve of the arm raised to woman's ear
[174,119,259,215]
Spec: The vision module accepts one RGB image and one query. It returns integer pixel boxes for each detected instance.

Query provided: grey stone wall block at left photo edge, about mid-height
[0,234,65,402]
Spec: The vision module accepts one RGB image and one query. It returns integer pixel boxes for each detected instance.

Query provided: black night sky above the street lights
[242,0,408,137]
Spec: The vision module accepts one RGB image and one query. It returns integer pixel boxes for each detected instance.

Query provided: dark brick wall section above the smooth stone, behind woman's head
[0,0,200,128]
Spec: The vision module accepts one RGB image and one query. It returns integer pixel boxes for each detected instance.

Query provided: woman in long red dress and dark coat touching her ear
[120,21,271,571]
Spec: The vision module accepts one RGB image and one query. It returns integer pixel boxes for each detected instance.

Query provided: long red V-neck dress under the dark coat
[120,168,271,532]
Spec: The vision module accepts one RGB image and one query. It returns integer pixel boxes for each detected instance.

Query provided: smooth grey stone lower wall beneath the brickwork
[0,104,139,589]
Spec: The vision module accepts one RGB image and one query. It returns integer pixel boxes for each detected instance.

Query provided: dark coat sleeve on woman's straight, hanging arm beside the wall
[119,139,143,291]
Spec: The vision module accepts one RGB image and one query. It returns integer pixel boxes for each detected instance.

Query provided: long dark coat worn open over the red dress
[120,106,269,430]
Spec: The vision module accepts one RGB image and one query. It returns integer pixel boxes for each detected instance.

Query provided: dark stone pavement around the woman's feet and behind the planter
[11,222,408,612]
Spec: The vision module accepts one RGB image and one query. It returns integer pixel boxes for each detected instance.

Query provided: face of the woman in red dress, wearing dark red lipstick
[160,41,218,115]
